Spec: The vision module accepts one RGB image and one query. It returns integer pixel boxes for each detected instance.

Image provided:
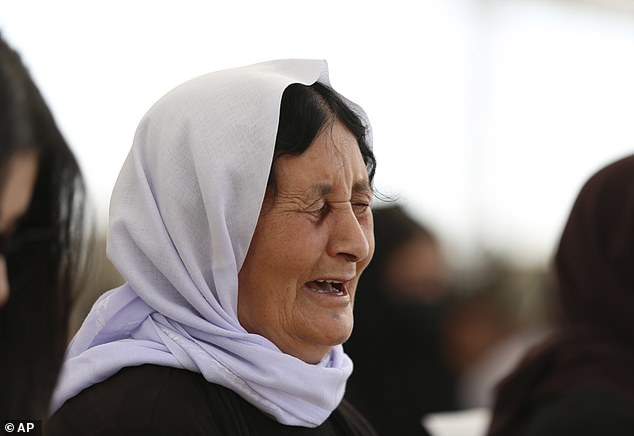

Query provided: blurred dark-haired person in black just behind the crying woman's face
[344,205,456,435]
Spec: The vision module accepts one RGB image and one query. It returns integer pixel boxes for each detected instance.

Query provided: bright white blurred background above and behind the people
[0,0,634,267]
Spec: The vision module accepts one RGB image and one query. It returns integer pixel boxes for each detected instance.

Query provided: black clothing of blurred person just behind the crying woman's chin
[344,295,450,436]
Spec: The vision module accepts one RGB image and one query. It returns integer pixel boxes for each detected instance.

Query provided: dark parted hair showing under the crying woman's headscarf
[269,82,376,186]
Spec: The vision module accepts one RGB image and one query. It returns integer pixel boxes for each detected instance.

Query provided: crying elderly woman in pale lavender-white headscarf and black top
[48,60,375,435]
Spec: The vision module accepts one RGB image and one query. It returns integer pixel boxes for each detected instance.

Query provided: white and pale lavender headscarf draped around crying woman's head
[52,60,369,427]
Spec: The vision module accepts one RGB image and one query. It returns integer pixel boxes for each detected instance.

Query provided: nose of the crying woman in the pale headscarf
[329,207,370,262]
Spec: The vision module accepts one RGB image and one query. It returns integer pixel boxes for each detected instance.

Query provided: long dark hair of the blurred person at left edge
[0,36,85,419]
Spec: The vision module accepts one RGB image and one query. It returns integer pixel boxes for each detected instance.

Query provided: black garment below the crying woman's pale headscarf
[45,365,376,436]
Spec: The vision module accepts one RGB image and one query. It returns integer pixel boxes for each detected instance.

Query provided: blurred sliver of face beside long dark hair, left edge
[0,152,38,307]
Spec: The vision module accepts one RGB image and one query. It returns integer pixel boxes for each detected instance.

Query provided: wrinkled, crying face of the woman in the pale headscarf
[238,121,374,363]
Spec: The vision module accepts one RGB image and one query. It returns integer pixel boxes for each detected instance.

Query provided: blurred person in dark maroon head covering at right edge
[488,156,634,436]
